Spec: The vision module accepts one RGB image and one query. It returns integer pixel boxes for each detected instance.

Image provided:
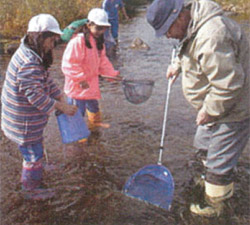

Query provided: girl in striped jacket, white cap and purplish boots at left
[1,14,77,200]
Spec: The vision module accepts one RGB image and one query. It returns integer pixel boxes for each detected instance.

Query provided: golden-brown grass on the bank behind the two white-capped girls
[0,0,147,37]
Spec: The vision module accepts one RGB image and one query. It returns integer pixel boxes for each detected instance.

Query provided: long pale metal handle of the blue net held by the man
[157,46,176,165]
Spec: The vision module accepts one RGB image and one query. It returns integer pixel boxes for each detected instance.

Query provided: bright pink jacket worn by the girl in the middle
[62,33,119,99]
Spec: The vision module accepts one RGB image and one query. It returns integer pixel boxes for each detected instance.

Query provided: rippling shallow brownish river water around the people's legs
[0,7,250,225]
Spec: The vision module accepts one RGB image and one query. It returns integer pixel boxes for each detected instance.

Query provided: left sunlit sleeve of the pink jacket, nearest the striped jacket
[62,35,85,81]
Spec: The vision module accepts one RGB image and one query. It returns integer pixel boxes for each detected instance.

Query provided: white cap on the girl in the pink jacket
[88,8,111,26]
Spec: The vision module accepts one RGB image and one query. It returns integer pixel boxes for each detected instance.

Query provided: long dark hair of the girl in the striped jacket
[24,31,55,70]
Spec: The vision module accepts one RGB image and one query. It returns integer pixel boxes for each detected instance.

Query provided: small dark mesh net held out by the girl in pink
[122,80,154,104]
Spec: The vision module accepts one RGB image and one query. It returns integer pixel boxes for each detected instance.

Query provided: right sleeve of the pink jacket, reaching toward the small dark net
[99,47,120,77]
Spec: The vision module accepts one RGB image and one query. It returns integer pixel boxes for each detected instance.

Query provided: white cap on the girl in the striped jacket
[27,14,63,35]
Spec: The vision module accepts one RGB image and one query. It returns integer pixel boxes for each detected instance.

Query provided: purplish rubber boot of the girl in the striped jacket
[21,161,55,200]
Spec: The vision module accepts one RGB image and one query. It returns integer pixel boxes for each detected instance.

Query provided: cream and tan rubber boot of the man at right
[190,181,234,217]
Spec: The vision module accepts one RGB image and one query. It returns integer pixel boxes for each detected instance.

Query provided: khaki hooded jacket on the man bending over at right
[178,0,250,122]
